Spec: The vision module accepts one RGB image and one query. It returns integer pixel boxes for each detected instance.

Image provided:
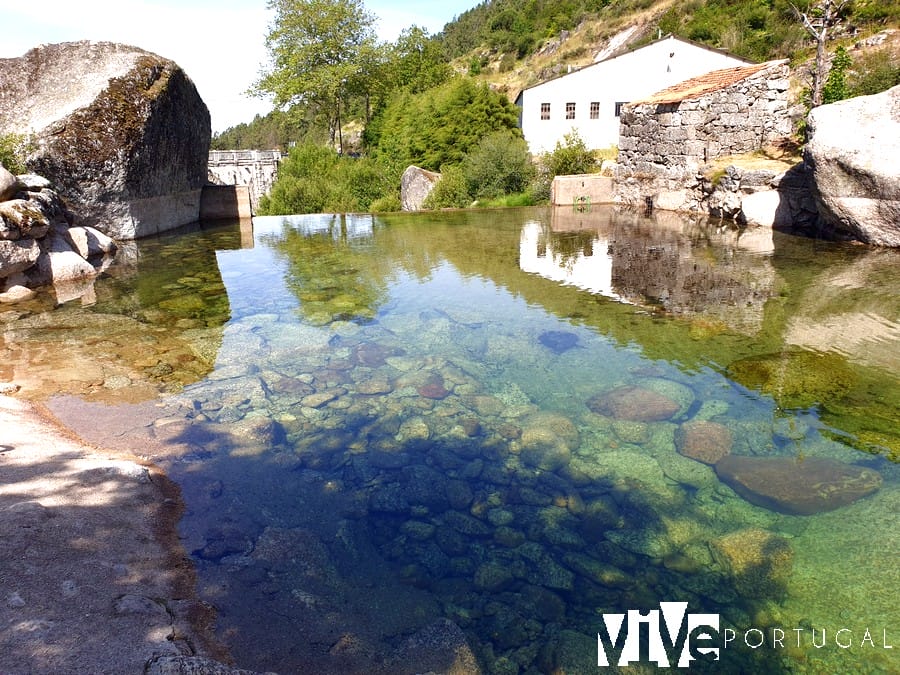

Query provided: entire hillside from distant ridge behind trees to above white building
[213,0,900,149]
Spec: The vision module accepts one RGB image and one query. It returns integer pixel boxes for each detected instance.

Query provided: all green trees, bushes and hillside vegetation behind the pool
[232,0,900,213]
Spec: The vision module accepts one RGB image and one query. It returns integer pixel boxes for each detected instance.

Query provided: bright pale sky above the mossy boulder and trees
[0,0,478,131]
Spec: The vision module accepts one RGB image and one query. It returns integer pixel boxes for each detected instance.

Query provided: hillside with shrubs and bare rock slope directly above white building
[436,0,900,98]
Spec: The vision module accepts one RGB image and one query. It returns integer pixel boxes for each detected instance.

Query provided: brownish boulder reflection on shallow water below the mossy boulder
[0,220,241,402]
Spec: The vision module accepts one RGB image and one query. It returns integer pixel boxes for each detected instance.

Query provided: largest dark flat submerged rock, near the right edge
[716,455,882,516]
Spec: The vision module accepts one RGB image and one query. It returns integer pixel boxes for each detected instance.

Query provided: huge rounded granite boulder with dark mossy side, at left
[0,42,210,239]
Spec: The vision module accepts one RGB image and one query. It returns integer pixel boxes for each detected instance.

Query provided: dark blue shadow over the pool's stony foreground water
[151,412,789,673]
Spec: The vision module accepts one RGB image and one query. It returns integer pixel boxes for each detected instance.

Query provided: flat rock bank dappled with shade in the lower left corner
[0,396,264,675]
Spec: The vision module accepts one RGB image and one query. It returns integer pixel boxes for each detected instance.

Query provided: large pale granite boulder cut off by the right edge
[805,86,900,246]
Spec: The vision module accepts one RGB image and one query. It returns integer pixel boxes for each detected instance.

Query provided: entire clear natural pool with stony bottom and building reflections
[0,209,900,674]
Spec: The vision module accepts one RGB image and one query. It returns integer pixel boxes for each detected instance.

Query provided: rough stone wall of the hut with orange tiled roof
[616,61,796,211]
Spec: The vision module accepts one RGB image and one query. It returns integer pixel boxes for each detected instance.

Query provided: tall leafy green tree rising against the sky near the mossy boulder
[251,0,375,152]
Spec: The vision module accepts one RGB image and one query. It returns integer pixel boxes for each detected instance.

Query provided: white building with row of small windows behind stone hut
[516,36,750,154]
